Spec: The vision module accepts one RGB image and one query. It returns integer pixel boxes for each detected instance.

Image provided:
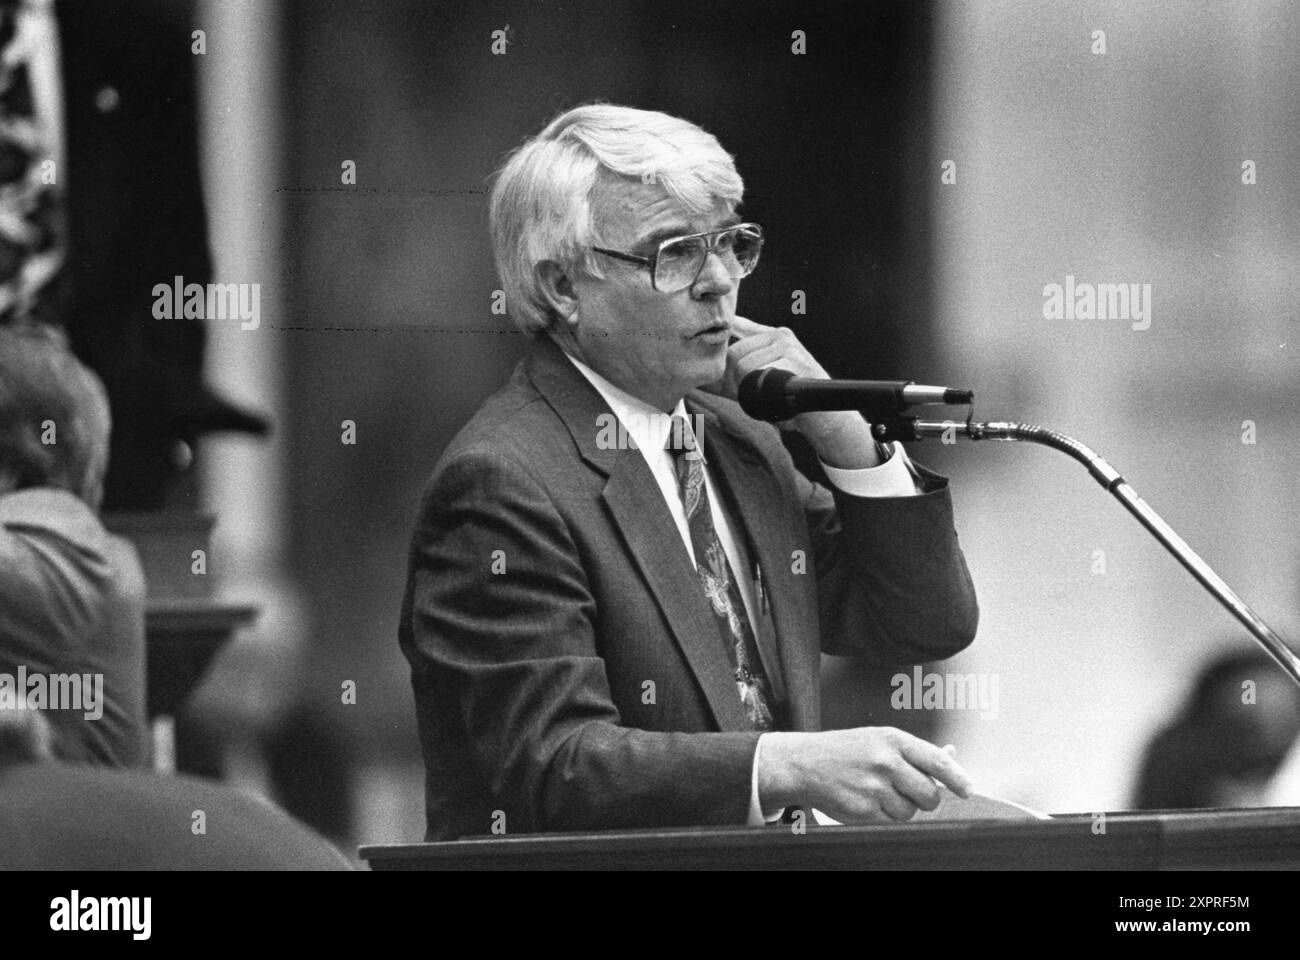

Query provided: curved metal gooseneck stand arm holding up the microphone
[871,416,1300,684]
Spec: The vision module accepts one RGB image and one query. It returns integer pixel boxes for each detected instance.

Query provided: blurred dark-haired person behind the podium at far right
[1135,650,1300,809]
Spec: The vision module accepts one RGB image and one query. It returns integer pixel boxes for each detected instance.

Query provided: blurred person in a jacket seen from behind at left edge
[0,327,148,766]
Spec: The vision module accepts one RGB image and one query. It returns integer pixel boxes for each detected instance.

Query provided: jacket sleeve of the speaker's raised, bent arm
[771,424,979,663]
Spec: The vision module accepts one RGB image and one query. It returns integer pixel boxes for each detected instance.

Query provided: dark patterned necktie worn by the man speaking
[666,416,776,730]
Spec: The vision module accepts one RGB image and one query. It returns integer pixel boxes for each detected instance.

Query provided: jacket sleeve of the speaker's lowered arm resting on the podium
[408,451,758,833]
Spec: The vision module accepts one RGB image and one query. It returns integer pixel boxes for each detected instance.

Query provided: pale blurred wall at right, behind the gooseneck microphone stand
[927,0,1300,810]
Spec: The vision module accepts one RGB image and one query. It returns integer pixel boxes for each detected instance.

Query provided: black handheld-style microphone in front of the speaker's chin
[737,367,975,421]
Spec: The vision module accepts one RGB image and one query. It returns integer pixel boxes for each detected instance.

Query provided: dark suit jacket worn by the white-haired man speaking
[399,337,978,839]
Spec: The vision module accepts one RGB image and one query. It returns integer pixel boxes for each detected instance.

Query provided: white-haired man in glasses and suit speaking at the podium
[399,104,979,840]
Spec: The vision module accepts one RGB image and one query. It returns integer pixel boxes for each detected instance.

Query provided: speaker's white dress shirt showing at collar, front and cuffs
[564,351,918,825]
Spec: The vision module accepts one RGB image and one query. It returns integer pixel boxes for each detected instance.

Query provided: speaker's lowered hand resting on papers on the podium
[758,727,971,823]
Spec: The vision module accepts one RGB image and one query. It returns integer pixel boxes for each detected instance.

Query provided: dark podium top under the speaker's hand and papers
[360,807,1300,870]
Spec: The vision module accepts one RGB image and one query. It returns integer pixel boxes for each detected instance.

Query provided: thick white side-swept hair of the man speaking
[490,103,745,336]
